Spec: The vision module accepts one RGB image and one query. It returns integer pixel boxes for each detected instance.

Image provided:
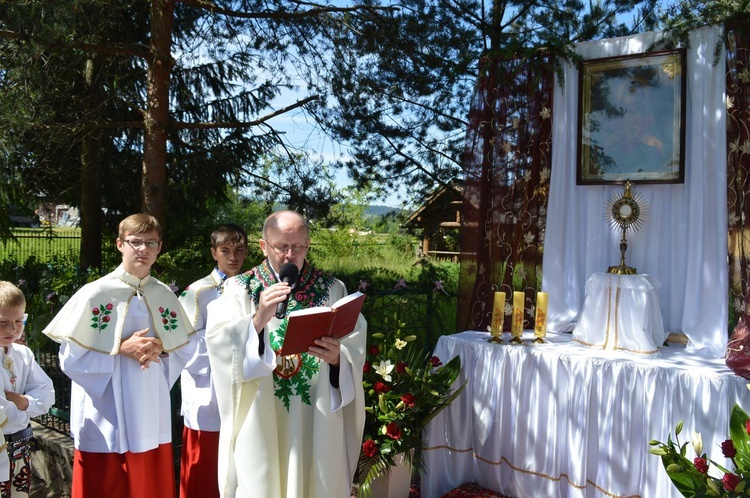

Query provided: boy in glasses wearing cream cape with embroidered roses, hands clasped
[44,214,195,498]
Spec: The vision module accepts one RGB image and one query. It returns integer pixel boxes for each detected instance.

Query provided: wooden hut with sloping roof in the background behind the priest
[402,184,463,260]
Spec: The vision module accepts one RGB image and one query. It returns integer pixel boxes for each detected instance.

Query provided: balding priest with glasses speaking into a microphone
[206,211,367,498]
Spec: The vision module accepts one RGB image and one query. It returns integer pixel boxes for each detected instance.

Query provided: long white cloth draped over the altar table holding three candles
[421,332,750,498]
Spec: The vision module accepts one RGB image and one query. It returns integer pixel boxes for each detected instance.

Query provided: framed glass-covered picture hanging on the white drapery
[576,49,685,185]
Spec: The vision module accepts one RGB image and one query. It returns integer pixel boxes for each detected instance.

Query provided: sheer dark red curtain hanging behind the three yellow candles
[457,53,554,330]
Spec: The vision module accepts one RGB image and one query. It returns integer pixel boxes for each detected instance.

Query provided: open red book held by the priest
[280,292,365,355]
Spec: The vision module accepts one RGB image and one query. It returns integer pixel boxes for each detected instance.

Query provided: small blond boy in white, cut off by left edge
[0,281,55,498]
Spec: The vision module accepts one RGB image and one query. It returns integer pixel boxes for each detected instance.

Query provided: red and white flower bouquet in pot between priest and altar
[354,316,464,496]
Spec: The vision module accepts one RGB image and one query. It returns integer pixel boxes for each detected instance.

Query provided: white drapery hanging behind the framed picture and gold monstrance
[542,27,729,357]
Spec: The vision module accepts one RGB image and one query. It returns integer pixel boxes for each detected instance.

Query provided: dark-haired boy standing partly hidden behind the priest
[180,223,247,498]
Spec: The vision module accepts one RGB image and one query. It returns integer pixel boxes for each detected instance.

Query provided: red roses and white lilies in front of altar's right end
[649,392,750,497]
